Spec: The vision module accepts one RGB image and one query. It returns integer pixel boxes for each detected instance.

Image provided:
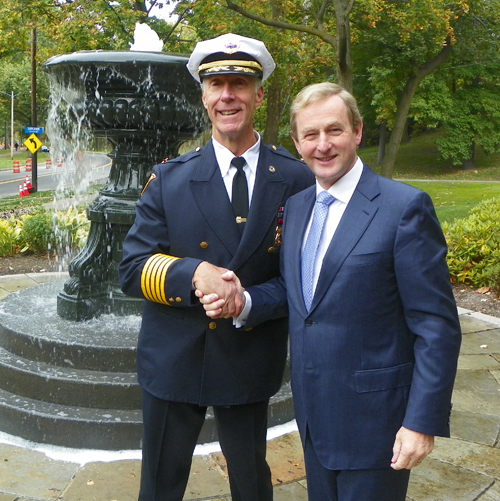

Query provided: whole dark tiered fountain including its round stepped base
[0,32,293,450]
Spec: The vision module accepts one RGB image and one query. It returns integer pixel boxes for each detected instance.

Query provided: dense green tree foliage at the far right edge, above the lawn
[437,0,500,168]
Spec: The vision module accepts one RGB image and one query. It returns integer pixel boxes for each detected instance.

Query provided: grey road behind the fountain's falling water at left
[0,153,111,198]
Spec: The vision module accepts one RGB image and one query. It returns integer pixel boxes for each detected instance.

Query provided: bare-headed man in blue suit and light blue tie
[197,83,461,501]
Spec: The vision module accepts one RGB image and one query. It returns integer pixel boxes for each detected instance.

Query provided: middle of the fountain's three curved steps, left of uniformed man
[0,347,141,410]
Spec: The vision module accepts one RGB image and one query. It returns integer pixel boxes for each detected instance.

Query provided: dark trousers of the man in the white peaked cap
[139,391,273,501]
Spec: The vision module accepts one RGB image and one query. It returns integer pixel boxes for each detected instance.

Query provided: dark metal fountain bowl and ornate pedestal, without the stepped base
[44,51,205,320]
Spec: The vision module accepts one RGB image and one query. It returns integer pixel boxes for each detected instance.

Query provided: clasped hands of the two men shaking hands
[193,261,245,319]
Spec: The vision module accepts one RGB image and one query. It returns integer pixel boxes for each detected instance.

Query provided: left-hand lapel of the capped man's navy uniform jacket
[190,141,240,255]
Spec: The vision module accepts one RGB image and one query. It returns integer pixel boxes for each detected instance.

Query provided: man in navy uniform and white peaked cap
[119,34,314,501]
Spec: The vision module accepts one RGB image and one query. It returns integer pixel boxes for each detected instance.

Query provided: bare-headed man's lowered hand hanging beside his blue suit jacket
[391,426,434,470]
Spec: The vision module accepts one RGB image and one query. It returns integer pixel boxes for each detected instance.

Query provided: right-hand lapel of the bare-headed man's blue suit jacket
[311,166,380,311]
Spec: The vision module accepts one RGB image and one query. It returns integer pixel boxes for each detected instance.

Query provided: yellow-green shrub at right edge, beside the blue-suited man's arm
[442,197,500,287]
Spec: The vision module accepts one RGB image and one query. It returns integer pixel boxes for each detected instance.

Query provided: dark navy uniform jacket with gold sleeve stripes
[119,141,314,405]
